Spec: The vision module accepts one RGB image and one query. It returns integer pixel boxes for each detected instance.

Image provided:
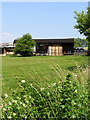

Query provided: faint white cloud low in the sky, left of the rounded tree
[0,32,20,43]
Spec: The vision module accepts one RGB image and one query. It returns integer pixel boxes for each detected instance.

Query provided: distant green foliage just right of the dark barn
[74,38,88,47]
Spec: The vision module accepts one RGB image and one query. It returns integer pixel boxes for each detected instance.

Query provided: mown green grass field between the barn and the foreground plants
[2,56,88,94]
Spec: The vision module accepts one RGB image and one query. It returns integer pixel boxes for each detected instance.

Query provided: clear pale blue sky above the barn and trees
[2,2,88,42]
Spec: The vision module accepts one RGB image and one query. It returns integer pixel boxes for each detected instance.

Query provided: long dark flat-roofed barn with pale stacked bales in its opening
[33,38,74,56]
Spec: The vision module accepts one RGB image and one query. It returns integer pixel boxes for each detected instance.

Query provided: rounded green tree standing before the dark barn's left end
[14,33,36,56]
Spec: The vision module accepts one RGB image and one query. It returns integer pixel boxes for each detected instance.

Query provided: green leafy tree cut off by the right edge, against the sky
[74,7,90,55]
